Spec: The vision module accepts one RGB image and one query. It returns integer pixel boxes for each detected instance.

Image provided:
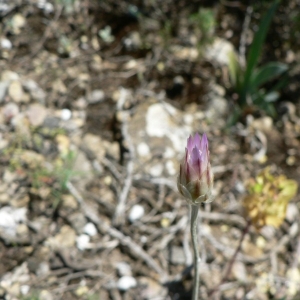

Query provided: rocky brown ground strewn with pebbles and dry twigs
[0,0,300,300]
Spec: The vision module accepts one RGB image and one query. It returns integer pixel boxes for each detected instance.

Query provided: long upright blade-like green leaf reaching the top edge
[241,0,280,105]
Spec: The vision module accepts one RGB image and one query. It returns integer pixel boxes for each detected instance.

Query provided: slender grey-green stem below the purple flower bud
[191,205,201,300]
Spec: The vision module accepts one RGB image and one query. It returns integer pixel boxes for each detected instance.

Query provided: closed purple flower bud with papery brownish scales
[177,133,214,205]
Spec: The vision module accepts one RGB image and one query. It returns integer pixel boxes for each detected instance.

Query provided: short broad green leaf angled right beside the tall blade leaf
[251,62,288,90]
